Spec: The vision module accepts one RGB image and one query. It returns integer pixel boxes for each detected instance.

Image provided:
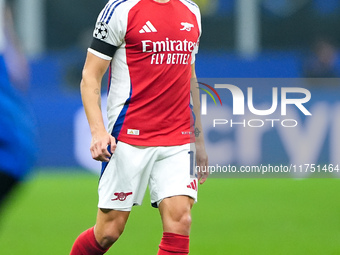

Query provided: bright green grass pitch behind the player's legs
[0,170,340,255]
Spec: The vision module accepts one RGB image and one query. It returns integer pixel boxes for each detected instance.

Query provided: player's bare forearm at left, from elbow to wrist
[80,73,105,135]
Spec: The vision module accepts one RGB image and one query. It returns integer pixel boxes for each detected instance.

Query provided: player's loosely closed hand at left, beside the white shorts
[90,132,117,162]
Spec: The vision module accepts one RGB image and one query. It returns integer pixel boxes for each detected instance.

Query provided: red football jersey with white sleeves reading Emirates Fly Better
[89,0,201,146]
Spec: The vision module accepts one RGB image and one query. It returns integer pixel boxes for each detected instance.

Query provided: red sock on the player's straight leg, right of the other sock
[157,232,189,255]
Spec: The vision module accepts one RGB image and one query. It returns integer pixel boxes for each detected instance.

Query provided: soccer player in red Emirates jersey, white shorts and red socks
[71,0,208,255]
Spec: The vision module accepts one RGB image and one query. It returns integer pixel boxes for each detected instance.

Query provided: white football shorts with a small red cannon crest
[98,141,197,211]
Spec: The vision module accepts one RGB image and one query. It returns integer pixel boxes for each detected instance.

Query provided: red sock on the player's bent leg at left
[70,227,108,255]
